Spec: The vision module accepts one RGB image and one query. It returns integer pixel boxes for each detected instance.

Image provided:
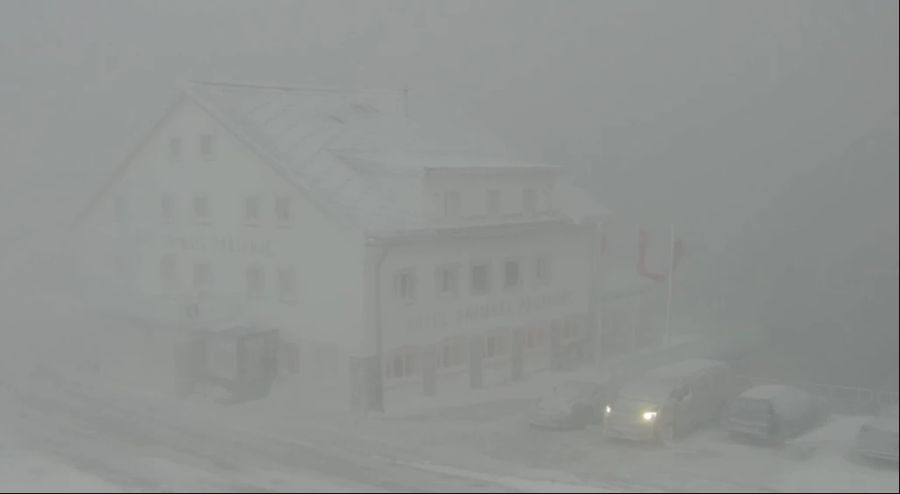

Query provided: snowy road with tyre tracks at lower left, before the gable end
[0,376,514,492]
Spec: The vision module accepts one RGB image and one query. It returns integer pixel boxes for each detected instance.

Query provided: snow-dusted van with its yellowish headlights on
[603,359,734,442]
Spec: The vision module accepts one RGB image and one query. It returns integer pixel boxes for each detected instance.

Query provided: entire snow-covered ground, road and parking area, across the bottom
[0,370,898,492]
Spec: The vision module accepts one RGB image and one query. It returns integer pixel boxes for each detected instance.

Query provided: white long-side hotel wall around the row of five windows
[381,227,592,351]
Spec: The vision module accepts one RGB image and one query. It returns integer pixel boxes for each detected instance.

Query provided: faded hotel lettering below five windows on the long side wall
[407,290,572,331]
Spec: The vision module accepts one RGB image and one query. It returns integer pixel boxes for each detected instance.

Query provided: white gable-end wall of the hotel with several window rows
[79,97,363,351]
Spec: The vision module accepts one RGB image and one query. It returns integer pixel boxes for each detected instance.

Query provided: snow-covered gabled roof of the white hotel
[77,82,603,235]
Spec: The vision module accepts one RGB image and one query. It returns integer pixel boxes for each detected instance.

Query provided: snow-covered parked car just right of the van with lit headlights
[725,384,825,442]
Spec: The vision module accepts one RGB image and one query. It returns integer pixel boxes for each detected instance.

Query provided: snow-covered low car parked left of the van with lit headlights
[528,377,612,429]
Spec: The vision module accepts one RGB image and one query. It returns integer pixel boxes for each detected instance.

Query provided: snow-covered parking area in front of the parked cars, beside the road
[392,401,898,492]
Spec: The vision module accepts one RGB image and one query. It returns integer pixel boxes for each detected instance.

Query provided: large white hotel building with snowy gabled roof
[79,83,605,407]
